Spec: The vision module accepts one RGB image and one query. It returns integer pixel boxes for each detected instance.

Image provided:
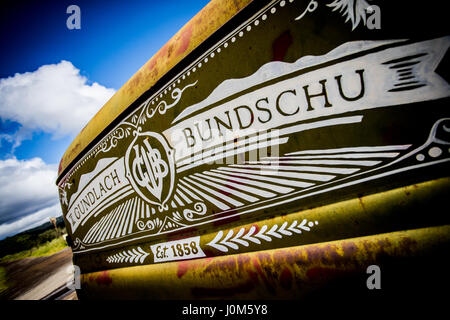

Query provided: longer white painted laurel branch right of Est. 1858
[207,219,319,252]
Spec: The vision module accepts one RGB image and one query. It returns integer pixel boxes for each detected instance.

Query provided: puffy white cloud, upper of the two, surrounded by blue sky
[0,60,114,139]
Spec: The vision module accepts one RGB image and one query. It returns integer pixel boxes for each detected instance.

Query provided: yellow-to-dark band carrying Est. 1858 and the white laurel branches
[74,178,450,277]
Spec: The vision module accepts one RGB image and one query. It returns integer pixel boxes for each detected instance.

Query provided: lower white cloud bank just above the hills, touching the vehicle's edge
[0,158,61,238]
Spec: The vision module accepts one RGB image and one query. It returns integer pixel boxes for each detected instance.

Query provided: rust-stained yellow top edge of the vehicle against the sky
[58,0,252,176]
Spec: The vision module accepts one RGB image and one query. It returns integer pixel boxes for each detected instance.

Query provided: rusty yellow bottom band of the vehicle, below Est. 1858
[79,226,450,299]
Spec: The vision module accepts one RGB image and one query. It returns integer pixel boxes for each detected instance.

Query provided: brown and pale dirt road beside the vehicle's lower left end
[1,248,76,300]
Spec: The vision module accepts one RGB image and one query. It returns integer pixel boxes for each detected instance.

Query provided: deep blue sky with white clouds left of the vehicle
[0,0,208,239]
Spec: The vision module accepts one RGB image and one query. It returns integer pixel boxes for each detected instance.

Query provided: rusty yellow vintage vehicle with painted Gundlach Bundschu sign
[57,0,450,299]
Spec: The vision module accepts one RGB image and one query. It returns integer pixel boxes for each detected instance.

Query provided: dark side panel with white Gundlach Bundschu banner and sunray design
[58,0,450,258]
